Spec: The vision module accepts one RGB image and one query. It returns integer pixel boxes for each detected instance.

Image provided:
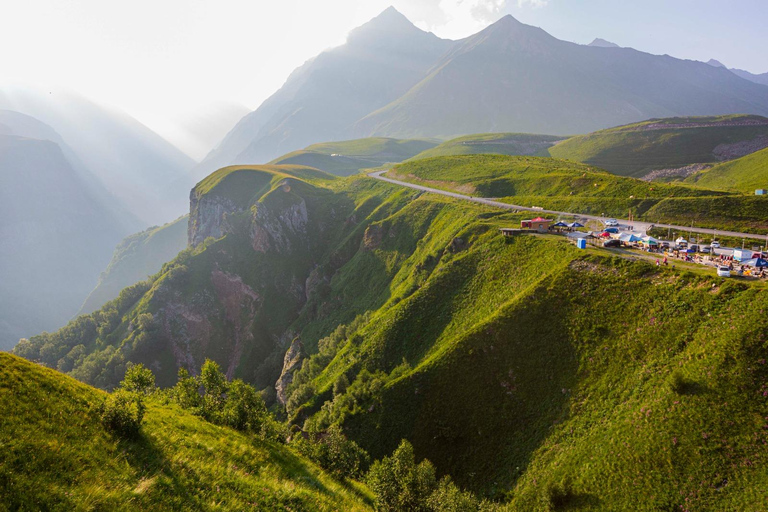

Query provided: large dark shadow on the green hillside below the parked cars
[345,276,588,500]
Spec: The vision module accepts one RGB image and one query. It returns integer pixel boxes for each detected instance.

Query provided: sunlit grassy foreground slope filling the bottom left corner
[0,353,369,510]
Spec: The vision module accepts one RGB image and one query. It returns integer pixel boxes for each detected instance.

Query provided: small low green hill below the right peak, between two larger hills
[404,133,564,160]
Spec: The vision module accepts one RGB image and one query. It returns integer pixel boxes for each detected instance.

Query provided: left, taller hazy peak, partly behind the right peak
[195,8,453,180]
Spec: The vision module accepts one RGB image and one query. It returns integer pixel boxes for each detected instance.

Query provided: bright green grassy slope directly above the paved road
[390,155,768,234]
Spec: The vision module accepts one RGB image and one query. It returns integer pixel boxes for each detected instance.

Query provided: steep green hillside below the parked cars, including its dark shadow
[288,199,768,510]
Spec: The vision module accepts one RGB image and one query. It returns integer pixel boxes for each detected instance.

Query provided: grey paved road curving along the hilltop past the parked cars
[368,170,768,243]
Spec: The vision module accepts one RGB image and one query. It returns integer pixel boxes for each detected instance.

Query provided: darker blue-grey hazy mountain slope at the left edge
[0,135,135,349]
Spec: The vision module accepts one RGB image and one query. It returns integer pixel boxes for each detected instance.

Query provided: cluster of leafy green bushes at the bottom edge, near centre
[366,440,501,512]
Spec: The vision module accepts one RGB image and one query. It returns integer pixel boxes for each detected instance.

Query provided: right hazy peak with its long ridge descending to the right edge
[355,16,768,137]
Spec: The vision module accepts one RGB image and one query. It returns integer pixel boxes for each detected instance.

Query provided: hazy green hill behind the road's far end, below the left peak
[270,137,437,176]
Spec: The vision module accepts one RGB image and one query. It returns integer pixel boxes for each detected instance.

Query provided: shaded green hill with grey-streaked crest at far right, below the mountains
[547,115,768,177]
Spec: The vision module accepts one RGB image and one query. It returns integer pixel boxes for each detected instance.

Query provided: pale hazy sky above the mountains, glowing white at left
[0,0,768,157]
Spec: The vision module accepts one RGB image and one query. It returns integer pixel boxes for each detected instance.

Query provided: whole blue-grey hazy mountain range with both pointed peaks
[193,8,768,179]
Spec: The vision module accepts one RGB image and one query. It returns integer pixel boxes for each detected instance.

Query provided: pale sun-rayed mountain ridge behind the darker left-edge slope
[0,88,194,224]
